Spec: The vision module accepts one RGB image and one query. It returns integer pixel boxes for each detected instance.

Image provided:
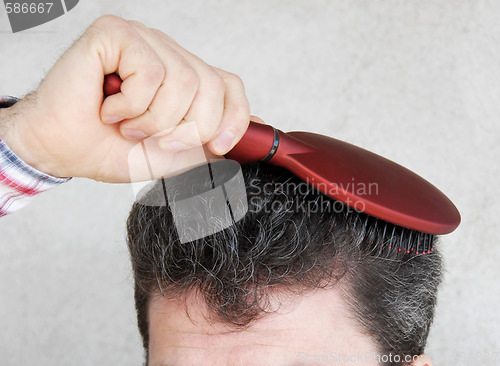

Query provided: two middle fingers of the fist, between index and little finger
[116,22,224,146]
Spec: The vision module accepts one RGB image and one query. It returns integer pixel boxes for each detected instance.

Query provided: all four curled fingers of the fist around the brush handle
[96,17,250,155]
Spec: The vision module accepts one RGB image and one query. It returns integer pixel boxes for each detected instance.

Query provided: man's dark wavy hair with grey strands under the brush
[127,163,442,365]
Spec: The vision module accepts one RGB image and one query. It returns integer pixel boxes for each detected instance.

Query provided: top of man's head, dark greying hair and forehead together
[128,163,441,366]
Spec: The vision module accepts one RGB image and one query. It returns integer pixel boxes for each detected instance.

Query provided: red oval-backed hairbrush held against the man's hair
[104,74,460,234]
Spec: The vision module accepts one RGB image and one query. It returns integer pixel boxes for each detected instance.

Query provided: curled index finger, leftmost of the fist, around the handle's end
[92,16,165,123]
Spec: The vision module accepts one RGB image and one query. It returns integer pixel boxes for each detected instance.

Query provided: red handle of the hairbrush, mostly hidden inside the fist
[103,74,280,164]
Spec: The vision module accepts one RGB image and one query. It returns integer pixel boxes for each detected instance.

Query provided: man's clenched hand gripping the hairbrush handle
[0,15,250,182]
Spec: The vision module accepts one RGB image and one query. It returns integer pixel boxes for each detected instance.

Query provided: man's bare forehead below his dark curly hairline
[149,289,374,366]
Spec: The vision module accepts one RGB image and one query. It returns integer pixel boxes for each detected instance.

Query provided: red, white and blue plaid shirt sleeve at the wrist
[0,96,70,217]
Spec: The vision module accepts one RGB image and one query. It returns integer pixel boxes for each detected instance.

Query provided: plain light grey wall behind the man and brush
[0,0,500,366]
